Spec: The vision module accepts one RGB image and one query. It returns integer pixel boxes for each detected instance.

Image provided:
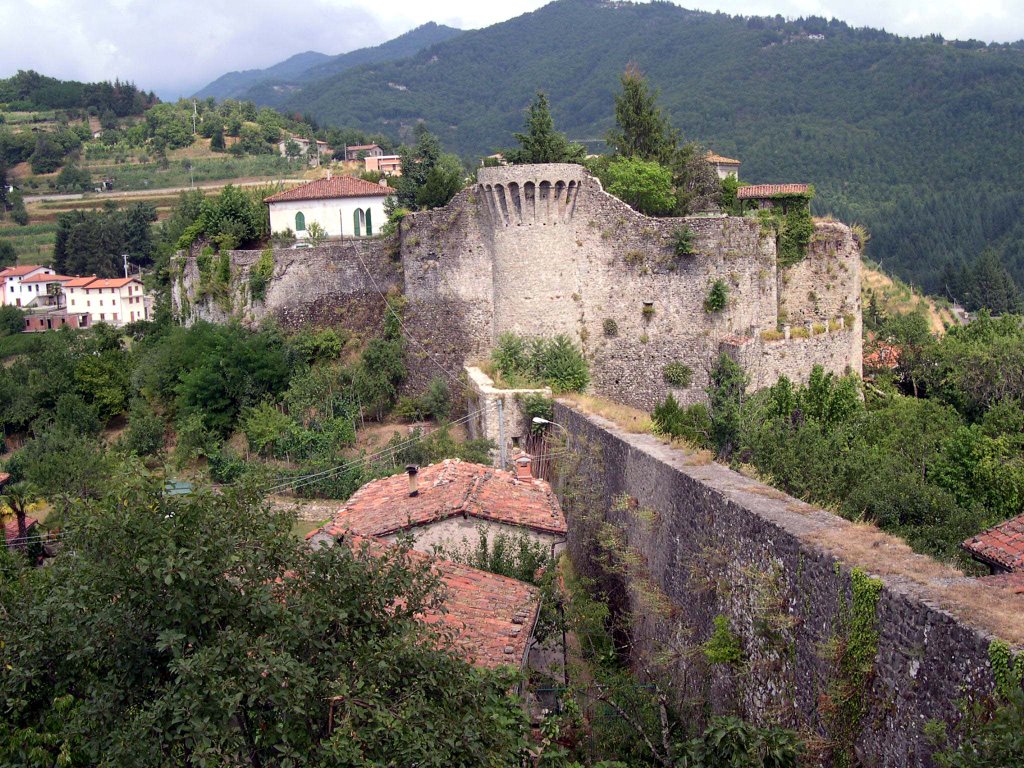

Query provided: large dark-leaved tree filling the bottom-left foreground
[0,473,526,768]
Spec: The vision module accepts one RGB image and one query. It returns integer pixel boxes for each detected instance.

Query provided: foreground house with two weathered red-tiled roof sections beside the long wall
[306,459,566,668]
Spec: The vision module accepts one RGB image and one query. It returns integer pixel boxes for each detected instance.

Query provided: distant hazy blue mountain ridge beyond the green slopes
[196,22,462,106]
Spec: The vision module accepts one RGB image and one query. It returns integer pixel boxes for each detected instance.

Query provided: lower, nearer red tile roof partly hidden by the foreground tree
[344,537,541,669]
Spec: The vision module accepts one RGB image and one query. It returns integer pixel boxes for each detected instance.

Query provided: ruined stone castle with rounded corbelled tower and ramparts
[174,159,861,409]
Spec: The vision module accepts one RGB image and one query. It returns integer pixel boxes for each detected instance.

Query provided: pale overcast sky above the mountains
[0,0,1024,98]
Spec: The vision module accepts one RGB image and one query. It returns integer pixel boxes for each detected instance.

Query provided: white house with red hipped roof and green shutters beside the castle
[263,175,391,240]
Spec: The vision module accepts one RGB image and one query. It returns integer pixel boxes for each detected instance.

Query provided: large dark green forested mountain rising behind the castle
[241,0,1024,294]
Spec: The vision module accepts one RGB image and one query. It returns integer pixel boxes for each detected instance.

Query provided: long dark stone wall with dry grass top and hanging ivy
[555,404,1024,768]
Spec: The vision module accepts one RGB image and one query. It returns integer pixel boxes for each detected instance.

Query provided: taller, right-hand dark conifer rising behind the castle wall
[607,63,679,164]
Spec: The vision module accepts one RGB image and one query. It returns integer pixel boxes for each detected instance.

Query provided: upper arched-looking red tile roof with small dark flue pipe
[317,459,566,537]
